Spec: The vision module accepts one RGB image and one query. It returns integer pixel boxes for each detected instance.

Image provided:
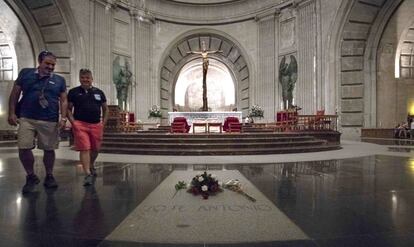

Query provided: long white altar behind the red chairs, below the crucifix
[168,111,243,125]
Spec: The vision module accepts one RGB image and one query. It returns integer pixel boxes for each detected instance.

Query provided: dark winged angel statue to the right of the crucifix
[279,55,298,109]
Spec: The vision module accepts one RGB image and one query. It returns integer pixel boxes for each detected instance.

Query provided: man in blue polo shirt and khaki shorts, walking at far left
[8,51,68,193]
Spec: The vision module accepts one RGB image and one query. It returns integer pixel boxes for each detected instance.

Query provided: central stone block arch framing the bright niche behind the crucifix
[160,30,251,116]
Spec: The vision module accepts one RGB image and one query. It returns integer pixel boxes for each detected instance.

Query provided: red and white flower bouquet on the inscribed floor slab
[187,172,223,199]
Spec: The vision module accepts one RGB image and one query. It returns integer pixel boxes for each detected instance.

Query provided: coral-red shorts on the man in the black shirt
[72,120,103,151]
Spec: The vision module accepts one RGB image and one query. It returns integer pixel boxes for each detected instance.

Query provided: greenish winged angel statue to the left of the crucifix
[112,56,132,111]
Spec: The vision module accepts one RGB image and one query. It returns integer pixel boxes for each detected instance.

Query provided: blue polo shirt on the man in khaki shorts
[15,68,66,122]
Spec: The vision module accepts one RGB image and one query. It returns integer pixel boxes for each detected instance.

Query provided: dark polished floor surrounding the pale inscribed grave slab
[0,155,414,247]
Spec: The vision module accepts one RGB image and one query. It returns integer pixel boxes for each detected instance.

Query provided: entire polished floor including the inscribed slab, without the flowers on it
[0,141,414,247]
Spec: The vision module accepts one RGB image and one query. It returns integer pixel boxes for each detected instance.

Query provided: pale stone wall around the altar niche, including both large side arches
[7,0,411,141]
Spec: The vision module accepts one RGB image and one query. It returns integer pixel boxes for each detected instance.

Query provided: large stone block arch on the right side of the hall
[325,0,403,139]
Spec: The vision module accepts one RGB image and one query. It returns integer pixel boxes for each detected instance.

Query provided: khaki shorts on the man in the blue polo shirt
[17,118,59,150]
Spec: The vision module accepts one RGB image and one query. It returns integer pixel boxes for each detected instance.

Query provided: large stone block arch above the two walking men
[5,0,86,85]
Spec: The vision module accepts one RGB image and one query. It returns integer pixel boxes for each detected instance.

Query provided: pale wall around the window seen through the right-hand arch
[377,1,414,128]
